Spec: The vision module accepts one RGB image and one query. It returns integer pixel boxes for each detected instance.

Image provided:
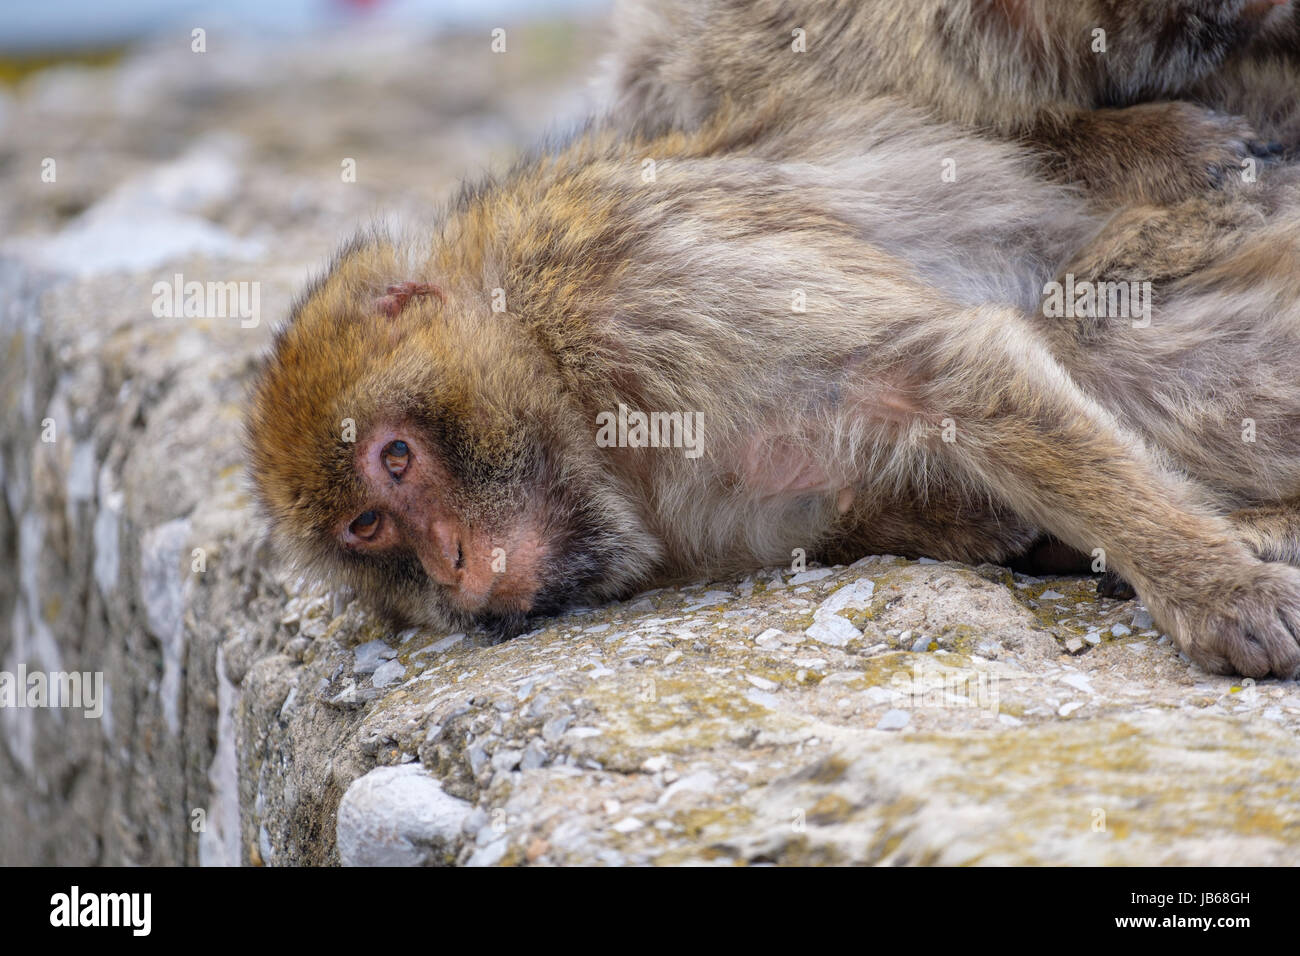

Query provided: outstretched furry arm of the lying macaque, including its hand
[911,308,1300,678]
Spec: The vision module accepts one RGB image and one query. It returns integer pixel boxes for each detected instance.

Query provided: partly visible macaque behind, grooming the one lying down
[611,0,1300,208]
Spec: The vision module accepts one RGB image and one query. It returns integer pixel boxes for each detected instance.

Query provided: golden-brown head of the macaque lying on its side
[247,234,655,633]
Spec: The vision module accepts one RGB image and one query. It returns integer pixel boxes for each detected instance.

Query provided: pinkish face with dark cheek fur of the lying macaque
[321,408,655,636]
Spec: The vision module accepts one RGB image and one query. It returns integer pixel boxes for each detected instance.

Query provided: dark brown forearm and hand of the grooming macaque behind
[1026,101,1281,206]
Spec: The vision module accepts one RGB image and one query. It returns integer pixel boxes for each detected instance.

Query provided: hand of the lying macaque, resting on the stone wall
[1147,562,1300,679]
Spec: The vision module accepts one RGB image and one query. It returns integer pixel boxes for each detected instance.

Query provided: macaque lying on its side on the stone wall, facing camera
[247,98,1300,678]
